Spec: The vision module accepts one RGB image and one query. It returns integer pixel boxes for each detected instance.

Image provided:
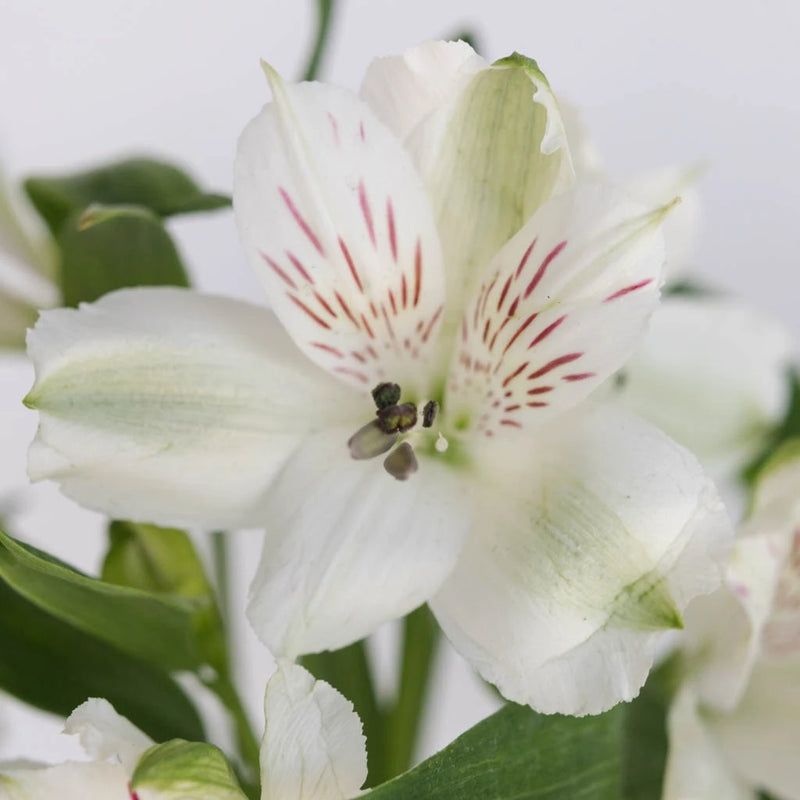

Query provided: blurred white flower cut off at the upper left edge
[0,159,58,349]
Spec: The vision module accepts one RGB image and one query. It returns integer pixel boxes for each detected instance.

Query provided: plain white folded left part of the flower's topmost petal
[360,42,489,140]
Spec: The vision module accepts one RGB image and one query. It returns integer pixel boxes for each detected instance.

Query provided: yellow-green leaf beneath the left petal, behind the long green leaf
[101,520,227,672]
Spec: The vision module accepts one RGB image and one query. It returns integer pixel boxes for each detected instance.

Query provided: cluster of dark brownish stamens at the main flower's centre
[347,383,447,481]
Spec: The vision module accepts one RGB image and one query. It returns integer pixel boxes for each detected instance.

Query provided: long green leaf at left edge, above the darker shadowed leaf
[0,532,208,670]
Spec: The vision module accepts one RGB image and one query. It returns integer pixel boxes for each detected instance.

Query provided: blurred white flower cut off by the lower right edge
[664,442,800,800]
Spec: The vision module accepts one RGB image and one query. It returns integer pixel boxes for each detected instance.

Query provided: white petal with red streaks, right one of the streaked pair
[445,185,666,434]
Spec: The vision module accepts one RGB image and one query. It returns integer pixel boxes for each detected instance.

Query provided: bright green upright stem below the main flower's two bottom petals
[385,606,441,779]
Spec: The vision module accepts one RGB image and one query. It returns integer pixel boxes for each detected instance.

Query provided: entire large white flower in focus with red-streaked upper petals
[27,43,729,714]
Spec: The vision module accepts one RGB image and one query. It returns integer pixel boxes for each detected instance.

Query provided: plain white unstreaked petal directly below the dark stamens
[248,429,470,658]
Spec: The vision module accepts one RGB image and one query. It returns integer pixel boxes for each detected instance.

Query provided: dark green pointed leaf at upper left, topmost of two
[25,158,230,235]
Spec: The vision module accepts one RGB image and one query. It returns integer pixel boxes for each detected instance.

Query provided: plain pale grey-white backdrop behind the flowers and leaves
[0,0,800,760]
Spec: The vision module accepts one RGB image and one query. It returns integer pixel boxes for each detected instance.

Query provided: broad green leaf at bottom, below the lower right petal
[363,705,624,800]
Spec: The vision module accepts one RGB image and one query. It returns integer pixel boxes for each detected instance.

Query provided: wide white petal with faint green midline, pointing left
[28,289,362,527]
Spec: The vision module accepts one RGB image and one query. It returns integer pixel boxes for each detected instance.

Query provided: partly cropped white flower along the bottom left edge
[0,663,367,800]
